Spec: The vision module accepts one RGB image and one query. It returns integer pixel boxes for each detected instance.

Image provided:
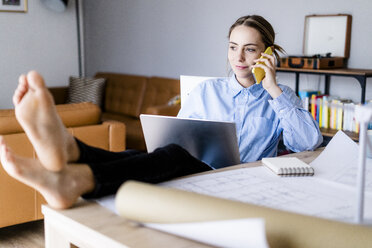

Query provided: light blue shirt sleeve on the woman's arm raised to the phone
[269,86,323,152]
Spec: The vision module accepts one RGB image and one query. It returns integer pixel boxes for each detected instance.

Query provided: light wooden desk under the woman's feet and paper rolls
[42,149,322,248]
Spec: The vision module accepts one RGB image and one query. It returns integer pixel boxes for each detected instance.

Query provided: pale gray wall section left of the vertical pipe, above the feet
[0,0,78,108]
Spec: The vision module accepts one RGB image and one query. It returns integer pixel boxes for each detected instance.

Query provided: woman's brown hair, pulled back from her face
[228,15,285,60]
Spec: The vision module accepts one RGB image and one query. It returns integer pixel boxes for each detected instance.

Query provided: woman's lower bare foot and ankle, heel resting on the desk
[0,137,94,209]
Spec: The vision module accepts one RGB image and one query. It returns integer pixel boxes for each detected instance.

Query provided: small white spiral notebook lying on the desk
[262,157,314,176]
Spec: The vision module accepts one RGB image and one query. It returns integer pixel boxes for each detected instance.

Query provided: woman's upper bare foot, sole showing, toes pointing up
[13,71,78,171]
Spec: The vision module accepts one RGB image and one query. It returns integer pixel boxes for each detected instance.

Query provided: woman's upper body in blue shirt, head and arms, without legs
[178,15,322,162]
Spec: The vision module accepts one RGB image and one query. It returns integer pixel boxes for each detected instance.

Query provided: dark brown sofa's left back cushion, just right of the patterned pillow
[95,73,147,118]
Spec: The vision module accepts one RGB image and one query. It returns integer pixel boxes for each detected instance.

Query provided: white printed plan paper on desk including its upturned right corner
[160,132,372,222]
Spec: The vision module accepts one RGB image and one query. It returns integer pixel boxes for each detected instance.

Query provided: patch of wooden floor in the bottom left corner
[0,220,44,248]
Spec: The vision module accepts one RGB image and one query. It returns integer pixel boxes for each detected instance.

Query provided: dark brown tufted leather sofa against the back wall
[52,72,180,150]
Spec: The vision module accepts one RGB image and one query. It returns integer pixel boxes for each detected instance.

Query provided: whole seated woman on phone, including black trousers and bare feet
[0,16,322,208]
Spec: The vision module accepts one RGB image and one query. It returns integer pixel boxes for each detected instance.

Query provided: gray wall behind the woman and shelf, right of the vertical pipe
[84,0,372,101]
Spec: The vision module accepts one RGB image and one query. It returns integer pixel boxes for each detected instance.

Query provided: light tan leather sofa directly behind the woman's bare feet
[0,103,125,227]
